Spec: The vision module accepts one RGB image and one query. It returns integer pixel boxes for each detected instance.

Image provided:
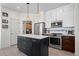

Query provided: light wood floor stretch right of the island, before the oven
[49,48,74,56]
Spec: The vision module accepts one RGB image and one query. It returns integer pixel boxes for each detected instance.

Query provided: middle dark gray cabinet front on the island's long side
[22,38,32,55]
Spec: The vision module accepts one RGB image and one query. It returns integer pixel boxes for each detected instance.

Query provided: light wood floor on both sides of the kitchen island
[0,45,74,56]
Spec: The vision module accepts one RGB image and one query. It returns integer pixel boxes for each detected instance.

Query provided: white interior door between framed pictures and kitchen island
[10,18,20,45]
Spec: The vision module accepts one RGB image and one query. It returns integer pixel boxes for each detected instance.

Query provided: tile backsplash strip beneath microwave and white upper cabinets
[46,27,74,35]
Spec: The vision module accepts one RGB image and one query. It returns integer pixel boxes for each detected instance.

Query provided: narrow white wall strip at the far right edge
[74,4,79,56]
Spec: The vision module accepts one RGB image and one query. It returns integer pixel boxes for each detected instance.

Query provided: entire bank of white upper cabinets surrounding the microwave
[45,4,74,28]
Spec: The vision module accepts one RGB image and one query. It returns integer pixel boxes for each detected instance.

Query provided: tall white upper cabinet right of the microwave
[63,4,74,27]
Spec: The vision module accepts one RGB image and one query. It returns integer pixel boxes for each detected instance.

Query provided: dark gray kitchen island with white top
[17,35,49,56]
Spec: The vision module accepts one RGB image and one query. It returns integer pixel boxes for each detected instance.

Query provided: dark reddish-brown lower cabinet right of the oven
[62,36,75,53]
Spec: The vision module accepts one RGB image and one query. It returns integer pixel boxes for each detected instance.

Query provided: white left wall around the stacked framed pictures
[1,7,21,48]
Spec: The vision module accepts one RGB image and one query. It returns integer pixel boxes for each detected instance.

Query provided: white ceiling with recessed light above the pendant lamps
[1,3,68,13]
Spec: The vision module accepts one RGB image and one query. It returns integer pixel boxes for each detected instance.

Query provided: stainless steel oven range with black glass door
[50,33,62,49]
